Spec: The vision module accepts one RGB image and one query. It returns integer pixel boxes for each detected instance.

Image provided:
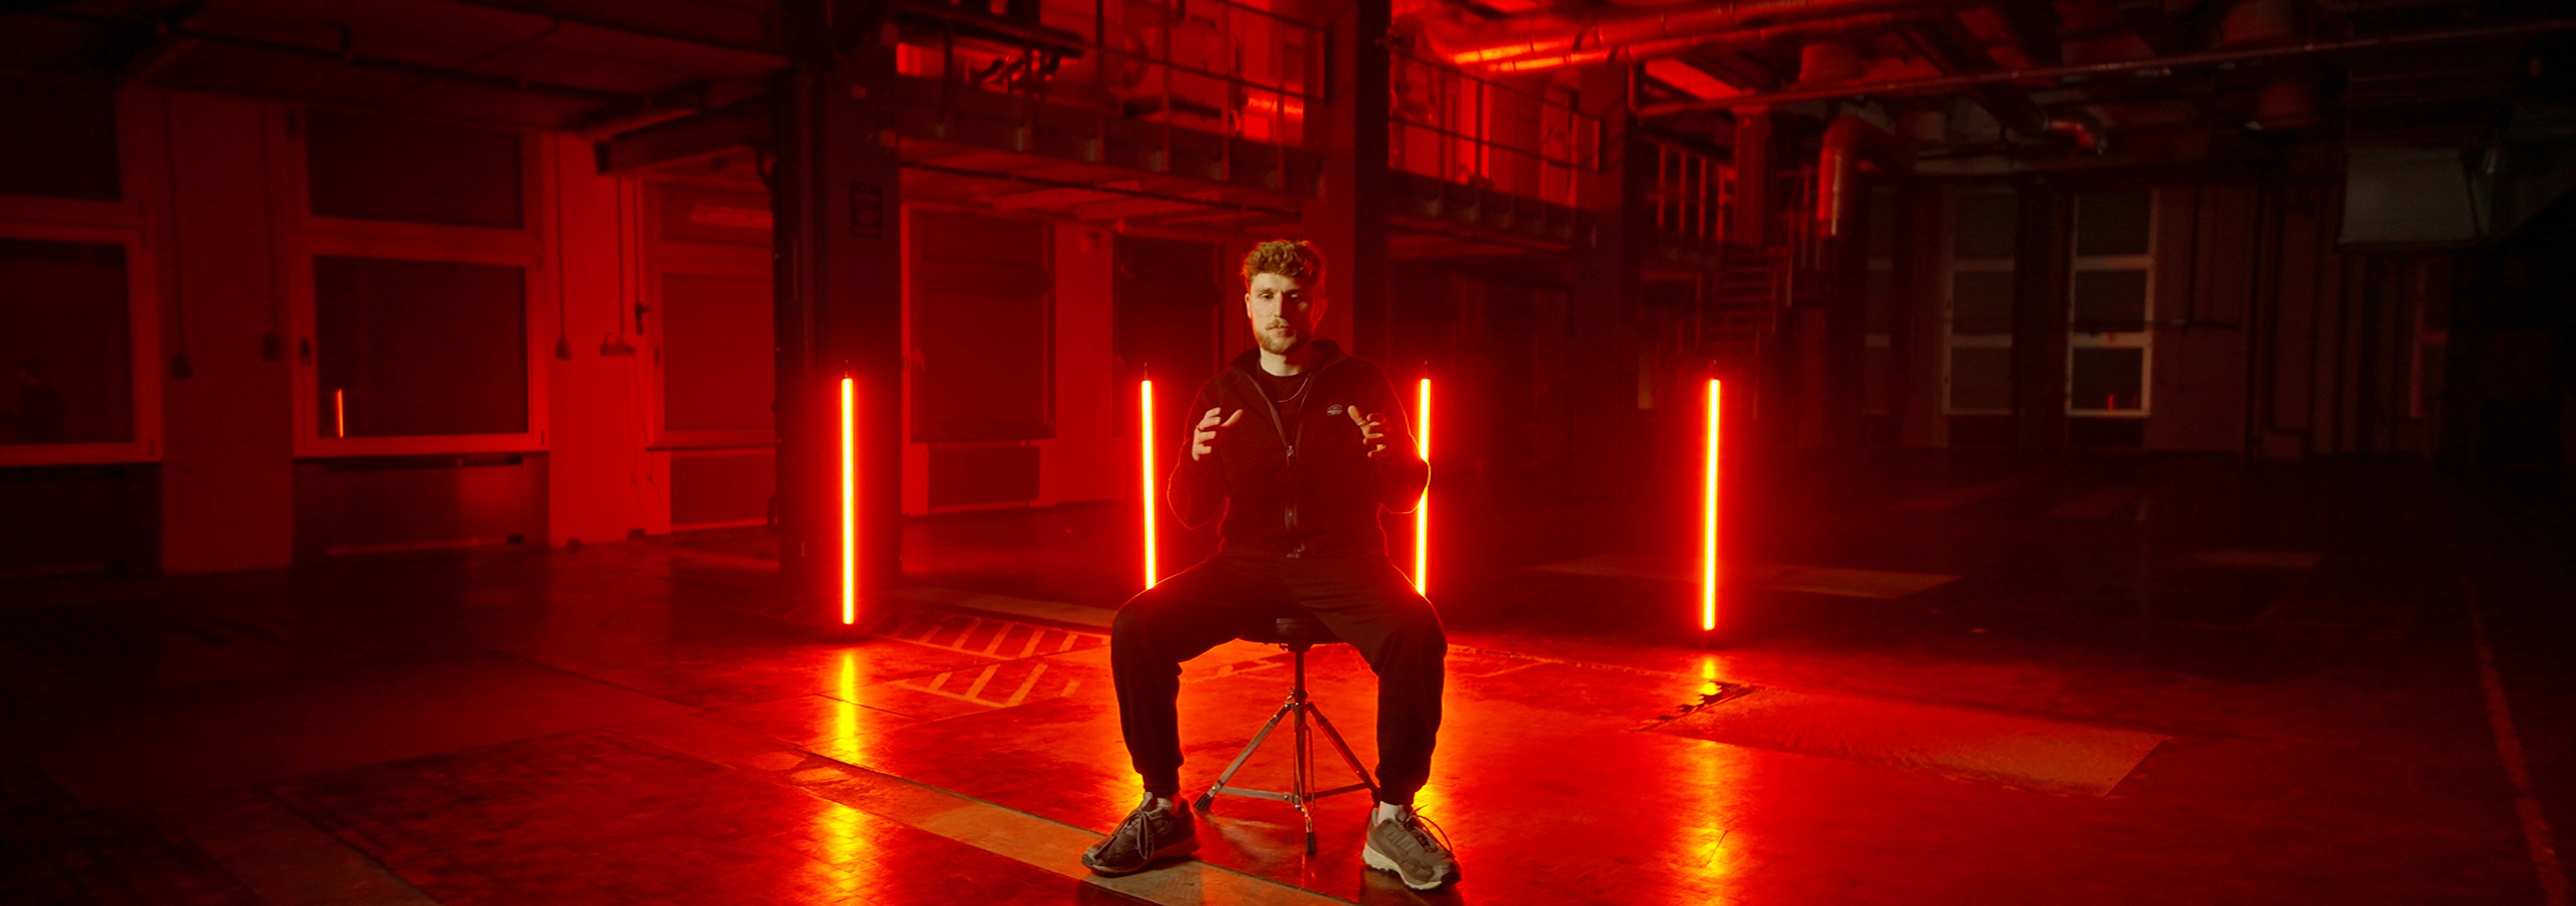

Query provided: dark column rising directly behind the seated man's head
[1301,3,1396,366]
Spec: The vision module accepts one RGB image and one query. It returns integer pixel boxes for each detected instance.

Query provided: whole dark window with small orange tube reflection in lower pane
[273,111,541,456]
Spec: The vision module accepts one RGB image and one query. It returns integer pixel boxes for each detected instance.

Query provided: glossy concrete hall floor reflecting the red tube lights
[0,456,2576,903]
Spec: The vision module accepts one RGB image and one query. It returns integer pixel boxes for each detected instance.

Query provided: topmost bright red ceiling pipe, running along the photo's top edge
[1450,0,1986,64]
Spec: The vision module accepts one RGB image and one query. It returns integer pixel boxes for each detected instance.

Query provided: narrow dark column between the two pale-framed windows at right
[2012,180,2076,450]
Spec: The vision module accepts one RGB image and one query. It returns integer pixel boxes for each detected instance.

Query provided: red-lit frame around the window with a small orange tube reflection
[268,105,561,458]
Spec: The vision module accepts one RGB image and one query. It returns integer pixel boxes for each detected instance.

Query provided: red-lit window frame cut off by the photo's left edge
[0,87,172,468]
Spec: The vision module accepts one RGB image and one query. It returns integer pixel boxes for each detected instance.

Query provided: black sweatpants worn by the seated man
[1110,554,1448,805]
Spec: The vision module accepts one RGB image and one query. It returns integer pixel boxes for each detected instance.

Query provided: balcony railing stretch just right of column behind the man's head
[1386,52,1602,206]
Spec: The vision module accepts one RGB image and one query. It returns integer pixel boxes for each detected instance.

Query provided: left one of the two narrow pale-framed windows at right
[1942,191,2020,414]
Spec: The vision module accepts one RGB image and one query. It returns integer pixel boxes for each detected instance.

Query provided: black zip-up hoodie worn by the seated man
[1169,340,1432,558]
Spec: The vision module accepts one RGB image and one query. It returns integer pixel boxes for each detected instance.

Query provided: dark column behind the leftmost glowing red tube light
[770,0,904,625]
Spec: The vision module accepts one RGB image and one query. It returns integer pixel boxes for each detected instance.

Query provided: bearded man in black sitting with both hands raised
[1082,240,1458,891]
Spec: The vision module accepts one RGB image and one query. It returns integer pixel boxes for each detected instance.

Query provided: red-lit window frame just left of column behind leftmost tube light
[636,180,778,453]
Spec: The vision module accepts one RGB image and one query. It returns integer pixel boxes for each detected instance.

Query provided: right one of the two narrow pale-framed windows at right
[2066,188,2156,417]
